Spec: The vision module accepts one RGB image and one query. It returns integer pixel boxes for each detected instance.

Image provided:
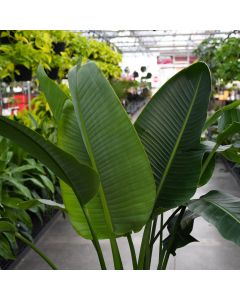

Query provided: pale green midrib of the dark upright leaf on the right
[156,74,202,199]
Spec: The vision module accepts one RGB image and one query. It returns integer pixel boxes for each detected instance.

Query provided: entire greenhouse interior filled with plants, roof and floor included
[0,30,240,270]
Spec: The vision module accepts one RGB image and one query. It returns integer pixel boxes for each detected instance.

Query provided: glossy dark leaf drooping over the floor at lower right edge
[188,191,240,246]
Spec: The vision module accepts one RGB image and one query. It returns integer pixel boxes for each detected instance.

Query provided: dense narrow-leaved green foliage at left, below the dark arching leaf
[0,137,61,260]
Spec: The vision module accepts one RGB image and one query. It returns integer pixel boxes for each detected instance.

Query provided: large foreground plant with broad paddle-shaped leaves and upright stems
[0,62,240,269]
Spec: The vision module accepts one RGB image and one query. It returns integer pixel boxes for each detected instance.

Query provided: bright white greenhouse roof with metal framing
[81,30,237,56]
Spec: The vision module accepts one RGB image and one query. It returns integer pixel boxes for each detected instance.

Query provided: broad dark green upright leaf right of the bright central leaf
[135,62,211,209]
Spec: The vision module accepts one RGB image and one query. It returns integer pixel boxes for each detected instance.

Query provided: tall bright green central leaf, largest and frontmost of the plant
[65,63,156,238]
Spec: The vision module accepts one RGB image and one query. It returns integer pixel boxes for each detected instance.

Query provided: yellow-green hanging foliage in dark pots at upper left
[0,30,121,81]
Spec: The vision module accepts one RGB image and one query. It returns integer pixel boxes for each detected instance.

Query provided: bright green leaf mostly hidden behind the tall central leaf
[58,100,109,239]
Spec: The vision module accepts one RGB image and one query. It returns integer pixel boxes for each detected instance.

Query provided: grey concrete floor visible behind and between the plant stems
[10,162,240,270]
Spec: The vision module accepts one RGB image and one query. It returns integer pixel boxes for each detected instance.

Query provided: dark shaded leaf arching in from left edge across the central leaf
[0,117,99,205]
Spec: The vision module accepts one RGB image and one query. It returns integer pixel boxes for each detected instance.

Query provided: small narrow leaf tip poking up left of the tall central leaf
[37,65,68,121]
